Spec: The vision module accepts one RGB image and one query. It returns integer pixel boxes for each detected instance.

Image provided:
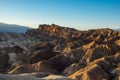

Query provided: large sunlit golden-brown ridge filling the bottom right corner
[69,52,120,80]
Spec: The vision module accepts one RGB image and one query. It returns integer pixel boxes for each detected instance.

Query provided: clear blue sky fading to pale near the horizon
[0,0,120,30]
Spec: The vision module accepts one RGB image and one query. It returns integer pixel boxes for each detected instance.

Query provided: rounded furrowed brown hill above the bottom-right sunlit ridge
[82,45,110,63]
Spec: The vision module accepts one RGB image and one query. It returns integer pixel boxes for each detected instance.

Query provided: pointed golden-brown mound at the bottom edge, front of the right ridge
[69,65,110,80]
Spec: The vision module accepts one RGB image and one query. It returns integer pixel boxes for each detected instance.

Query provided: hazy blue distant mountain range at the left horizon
[0,23,31,33]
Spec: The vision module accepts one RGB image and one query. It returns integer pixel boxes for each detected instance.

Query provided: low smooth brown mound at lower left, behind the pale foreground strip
[8,61,57,74]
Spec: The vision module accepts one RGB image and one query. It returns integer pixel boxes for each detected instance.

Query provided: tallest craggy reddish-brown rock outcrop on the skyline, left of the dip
[26,24,79,38]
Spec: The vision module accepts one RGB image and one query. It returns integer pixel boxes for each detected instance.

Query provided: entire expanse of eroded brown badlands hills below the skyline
[0,24,120,80]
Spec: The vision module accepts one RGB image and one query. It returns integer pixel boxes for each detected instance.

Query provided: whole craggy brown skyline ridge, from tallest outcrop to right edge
[26,24,120,41]
